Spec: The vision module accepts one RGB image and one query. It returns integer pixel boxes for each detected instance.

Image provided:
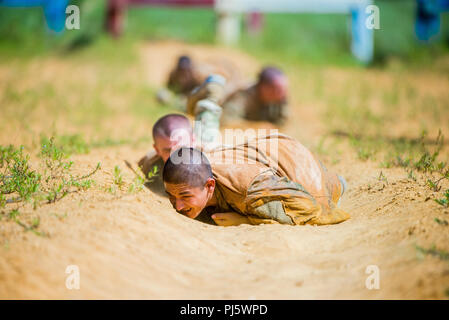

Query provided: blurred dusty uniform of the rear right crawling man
[222,85,288,124]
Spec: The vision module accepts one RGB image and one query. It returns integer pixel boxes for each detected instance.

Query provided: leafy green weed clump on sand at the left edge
[0,138,100,235]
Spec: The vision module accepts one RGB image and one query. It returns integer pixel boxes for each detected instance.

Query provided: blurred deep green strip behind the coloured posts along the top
[0,0,449,65]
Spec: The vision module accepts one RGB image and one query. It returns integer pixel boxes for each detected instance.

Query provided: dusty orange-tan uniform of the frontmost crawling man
[200,134,349,225]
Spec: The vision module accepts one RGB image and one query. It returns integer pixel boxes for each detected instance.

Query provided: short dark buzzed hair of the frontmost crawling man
[162,147,213,187]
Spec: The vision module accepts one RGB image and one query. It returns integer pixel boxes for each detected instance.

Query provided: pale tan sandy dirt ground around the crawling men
[0,42,449,299]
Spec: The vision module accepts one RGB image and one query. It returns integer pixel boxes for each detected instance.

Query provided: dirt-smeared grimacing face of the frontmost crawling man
[164,178,215,219]
